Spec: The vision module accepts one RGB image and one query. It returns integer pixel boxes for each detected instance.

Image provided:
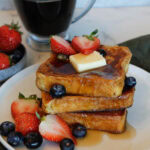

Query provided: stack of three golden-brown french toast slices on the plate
[36,40,135,133]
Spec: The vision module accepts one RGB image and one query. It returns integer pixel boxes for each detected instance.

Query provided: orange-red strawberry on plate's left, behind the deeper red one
[11,99,38,119]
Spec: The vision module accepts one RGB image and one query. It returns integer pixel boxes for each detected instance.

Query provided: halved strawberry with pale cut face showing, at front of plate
[39,115,76,144]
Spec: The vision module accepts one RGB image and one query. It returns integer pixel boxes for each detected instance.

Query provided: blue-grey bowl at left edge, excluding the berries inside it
[0,46,27,82]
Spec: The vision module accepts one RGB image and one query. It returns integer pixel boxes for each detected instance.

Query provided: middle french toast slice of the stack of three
[41,88,135,114]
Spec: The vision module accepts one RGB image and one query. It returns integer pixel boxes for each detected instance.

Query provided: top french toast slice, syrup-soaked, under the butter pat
[36,46,132,97]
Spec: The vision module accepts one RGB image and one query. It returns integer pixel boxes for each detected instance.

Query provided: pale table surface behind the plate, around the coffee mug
[0,7,150,66]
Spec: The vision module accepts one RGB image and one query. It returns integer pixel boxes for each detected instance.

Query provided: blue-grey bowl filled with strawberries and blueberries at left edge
[0,22,26,82]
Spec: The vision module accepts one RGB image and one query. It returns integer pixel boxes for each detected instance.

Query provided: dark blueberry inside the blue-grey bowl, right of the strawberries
[11,45,25,64]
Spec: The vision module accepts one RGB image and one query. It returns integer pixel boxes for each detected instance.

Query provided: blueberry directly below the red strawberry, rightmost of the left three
[24,132,43,149]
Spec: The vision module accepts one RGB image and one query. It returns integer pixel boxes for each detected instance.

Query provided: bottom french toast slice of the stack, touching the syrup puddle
[57,109,127,133]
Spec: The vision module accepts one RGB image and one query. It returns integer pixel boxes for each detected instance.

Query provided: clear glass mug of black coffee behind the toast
[14,0,96,51]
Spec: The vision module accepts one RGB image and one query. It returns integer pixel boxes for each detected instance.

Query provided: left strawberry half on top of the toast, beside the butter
[50,36,76,55]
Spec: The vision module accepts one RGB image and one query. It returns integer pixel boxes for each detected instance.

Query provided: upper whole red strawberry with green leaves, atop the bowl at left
[0,22,22,52]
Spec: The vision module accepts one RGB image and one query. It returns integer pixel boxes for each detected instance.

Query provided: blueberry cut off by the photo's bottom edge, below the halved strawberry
[59,138,74,150]
